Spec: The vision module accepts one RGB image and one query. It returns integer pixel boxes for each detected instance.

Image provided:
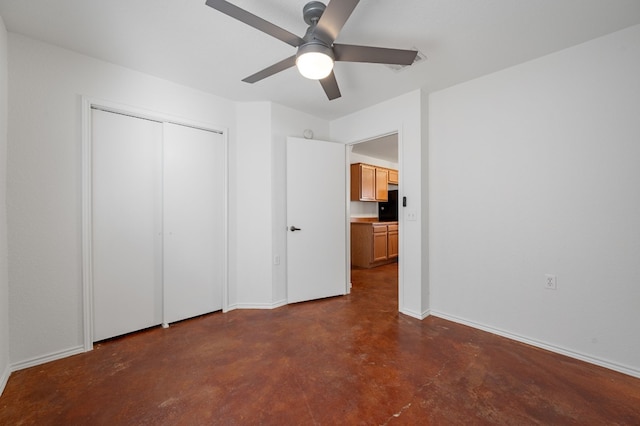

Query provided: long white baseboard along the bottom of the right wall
[431,311,640,378]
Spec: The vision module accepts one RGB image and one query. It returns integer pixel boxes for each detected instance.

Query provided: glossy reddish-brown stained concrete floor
[0,264,640,425]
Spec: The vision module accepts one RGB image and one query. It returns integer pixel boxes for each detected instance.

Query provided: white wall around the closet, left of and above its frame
[6,34,240,368]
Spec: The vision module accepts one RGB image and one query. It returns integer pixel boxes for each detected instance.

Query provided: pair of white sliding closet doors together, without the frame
[91,110,227,341]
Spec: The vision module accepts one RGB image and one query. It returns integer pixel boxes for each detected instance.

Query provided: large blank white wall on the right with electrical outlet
[429,26,640,376]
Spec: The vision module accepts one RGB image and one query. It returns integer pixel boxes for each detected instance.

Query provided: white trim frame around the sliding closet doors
[81,96,229,352]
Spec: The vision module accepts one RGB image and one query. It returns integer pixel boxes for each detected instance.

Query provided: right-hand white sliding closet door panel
[163,123,226,323]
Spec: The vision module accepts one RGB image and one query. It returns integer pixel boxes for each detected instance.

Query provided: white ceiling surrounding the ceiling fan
[0,0,640,119]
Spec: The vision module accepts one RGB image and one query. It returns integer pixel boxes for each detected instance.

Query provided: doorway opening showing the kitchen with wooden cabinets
[348,132,401,300]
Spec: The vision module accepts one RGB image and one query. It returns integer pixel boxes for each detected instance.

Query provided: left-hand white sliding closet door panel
[91,110,162,341]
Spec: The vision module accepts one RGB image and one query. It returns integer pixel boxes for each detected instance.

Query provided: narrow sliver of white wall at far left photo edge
[0,16,9,394]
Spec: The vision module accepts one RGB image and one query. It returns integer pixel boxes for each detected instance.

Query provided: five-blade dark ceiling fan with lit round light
[206,0,418,100]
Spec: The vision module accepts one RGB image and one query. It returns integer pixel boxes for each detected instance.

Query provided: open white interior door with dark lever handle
[287,138,347,303]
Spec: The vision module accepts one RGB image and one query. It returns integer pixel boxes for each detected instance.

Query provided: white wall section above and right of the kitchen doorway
[331,90,429,318]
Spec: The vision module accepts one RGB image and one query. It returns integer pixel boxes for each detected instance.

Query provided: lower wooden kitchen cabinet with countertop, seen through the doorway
[351,222,398,268]
